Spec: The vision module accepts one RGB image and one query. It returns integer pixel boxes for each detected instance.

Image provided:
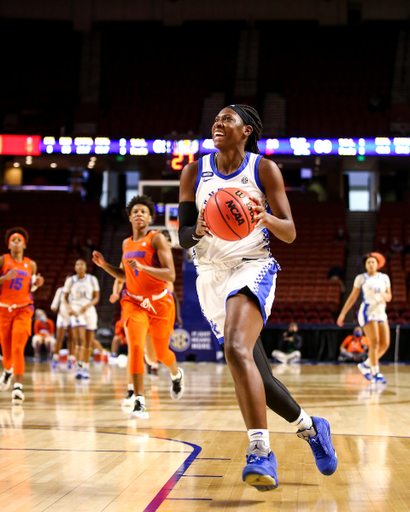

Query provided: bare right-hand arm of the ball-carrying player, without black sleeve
[252,158,296,244]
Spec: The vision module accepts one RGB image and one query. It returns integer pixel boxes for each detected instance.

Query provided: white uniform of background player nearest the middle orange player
[64,274,100,331]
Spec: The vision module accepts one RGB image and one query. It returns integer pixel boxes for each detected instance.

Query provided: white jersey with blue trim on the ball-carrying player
[193,152,272,267]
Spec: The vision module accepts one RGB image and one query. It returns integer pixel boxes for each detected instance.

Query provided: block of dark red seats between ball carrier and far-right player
[268,203,346,324]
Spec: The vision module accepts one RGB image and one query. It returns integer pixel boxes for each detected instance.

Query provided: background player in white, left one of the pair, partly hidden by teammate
[50,276,75,370]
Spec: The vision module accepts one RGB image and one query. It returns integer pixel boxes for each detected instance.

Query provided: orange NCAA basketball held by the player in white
[204,188,256,242]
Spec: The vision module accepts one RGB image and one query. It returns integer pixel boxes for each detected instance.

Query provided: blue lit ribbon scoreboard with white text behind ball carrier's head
[40,137,410,160]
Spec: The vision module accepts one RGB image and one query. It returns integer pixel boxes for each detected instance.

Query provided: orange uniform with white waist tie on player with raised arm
[121,230,175,374]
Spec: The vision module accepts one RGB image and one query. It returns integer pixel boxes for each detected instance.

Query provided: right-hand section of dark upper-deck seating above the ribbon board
[257,21,399,138]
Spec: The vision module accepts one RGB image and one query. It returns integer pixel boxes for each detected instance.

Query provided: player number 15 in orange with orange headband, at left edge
[0,227,44,404]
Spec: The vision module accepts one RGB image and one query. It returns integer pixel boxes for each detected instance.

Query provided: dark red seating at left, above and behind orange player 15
[0,192,101,312]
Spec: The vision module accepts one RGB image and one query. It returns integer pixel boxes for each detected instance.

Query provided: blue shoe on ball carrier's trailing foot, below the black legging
[296,416,337,475]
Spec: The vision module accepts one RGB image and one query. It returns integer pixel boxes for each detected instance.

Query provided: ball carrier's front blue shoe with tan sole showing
[242,452,278,492]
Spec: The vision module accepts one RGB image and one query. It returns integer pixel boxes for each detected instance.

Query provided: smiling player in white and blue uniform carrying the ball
[179,105,337,491]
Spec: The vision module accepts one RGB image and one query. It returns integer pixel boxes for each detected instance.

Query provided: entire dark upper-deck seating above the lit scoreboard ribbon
[0,20,401,138]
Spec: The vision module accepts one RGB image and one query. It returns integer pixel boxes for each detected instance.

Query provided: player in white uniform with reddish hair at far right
[337,252,392,384]
